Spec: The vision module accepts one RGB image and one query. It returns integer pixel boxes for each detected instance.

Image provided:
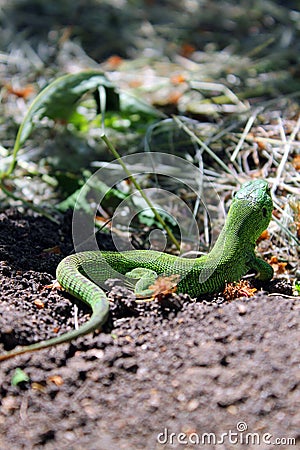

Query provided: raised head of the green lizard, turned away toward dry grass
[228,180,273,243]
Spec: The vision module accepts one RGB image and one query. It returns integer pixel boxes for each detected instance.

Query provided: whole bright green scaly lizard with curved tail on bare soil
[0,180,273,361]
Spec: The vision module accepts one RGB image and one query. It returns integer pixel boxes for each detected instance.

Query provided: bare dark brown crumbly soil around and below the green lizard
[0,210,300,450]
